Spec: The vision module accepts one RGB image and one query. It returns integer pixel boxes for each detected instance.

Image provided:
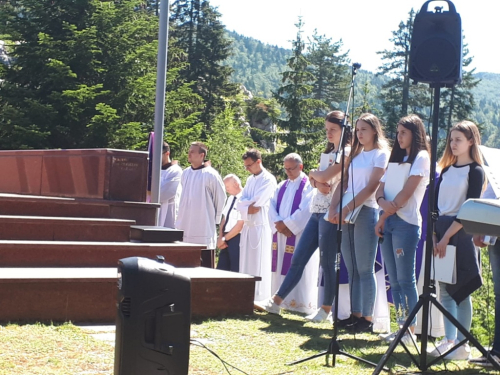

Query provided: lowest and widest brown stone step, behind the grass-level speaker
[0,267,258,323]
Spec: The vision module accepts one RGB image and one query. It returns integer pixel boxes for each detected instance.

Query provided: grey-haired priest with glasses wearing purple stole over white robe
[269,153,319,314]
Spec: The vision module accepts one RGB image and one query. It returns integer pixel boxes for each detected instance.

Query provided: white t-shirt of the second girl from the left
[346,148,390,208]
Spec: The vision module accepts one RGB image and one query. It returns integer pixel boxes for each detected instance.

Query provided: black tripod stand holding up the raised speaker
[373,84,500,374]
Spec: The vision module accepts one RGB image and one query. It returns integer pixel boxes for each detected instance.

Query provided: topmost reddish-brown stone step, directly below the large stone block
[0,193,160,225]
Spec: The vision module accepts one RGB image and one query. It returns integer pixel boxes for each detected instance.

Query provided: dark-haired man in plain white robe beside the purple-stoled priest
[238,149,277,300]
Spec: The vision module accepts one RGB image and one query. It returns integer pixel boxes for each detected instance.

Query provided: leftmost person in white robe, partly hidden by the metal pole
[158,142,182,228]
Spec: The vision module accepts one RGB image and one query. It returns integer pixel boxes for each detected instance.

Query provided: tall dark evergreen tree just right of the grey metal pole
[171,0,238,131]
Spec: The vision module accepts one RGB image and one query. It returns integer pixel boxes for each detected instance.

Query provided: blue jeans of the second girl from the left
[342,206,378,316]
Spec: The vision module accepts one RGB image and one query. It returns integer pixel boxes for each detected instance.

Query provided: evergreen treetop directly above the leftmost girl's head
[307,30,349,110]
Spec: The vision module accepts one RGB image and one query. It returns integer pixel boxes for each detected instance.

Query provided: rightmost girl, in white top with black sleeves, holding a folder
[429,121,485,360]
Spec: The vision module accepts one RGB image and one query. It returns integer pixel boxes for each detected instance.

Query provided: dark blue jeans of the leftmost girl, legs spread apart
[276,213,337,306]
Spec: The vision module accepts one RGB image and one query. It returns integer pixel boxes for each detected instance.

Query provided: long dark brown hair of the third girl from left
[389,114,430,164]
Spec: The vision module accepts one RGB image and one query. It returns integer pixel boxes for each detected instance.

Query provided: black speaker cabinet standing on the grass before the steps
[114,257,191,375]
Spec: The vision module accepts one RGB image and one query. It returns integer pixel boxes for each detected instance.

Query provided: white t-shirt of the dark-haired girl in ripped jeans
[382,150,431,226]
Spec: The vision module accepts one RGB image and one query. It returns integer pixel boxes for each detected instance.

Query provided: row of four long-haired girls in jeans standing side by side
[256,111,486,359]
